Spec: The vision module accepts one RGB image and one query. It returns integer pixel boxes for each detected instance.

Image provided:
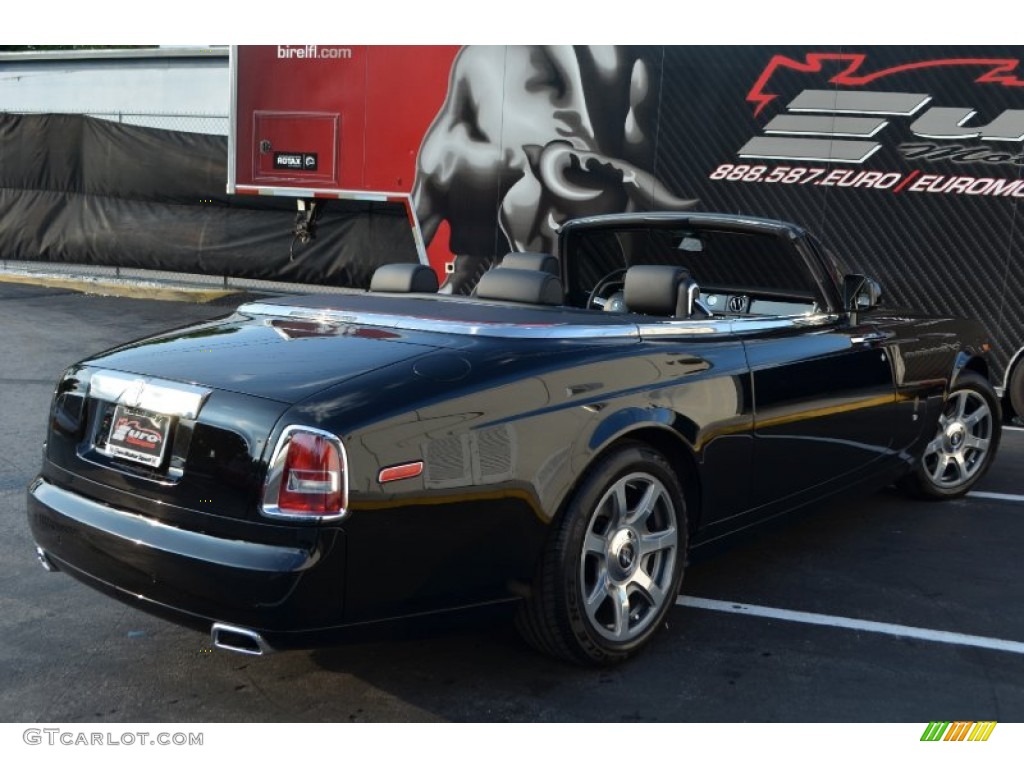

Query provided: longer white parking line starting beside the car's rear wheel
[676,595,1024,654]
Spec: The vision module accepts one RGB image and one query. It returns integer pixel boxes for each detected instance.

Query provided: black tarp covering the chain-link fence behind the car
[0,114,416,288]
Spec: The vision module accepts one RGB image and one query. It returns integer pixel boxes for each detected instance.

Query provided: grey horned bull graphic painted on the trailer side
[413,46,696,290]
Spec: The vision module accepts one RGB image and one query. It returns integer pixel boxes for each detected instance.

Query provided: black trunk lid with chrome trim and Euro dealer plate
[43,305,442,528]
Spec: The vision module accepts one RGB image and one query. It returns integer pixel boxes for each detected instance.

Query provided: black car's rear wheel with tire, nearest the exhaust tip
[517,443,687,665]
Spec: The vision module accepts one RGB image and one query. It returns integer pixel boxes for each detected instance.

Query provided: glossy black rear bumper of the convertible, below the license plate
[28,478,345,635]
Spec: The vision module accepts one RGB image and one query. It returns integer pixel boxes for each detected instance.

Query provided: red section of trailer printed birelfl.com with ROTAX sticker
[227,45,459,273]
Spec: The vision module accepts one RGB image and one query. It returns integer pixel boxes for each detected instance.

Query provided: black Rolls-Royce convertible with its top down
[28,213,1000,664]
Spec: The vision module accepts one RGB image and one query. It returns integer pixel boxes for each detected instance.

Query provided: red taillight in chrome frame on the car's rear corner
[263,427,346,518]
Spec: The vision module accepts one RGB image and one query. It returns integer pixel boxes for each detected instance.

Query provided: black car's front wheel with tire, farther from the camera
[902,371,1002,499]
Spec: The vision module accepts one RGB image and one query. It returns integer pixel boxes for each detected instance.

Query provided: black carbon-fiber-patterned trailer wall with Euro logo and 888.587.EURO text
[644,46,1024,382]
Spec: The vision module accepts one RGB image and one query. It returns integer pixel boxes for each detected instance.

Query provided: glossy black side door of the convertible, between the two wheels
[734,315,896,508]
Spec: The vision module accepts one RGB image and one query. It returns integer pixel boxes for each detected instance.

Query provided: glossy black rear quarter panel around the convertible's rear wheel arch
[281,339,751,622]
